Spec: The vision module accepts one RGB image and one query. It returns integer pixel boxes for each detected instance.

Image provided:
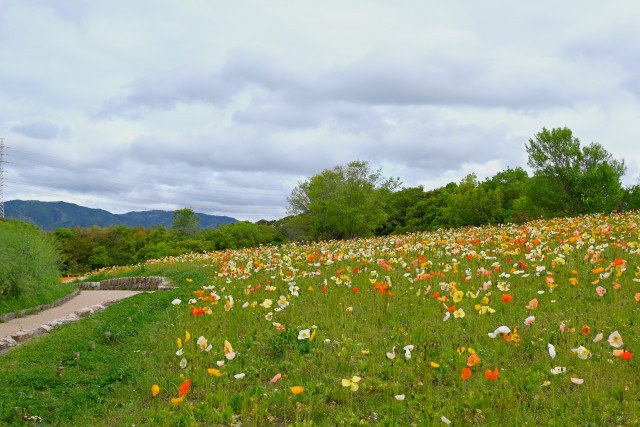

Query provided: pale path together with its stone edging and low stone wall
[0,276,175,354]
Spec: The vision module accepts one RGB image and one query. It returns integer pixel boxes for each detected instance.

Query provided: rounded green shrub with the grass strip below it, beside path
[0,221,73,314]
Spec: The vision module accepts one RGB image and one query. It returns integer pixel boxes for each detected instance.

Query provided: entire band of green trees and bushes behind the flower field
[52,128,640,274]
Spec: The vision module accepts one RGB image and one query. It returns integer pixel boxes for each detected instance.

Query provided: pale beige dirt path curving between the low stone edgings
[0,291,140,339]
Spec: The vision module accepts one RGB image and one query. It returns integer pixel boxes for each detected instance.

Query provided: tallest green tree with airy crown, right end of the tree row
[526,127,626,216]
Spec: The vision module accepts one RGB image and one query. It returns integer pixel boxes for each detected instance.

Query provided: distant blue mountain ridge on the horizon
[4,200,238,231]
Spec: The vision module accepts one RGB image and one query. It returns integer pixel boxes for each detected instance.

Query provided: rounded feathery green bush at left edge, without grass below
[0,221,60,301]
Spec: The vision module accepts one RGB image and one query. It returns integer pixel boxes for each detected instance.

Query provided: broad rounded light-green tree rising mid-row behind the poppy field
[287,161,399,239]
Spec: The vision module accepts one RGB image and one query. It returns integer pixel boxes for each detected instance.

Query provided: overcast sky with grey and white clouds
[0,0,640,221]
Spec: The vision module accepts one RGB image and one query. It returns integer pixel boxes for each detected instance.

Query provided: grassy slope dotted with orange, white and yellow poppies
[0,213,640,426]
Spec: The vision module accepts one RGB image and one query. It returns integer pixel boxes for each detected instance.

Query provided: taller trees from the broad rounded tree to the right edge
[285,127,640,239]
